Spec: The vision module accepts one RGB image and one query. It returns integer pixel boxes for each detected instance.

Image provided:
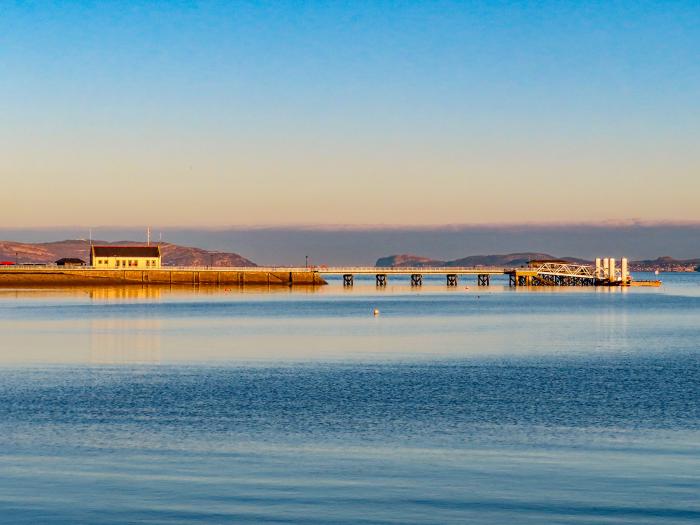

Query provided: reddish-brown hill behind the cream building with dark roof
[0,239,257,266]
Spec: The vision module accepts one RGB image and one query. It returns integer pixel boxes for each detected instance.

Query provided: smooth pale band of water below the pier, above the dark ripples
[0,276,700,365]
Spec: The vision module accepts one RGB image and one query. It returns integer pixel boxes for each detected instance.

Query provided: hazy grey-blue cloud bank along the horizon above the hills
[0,223,700,265]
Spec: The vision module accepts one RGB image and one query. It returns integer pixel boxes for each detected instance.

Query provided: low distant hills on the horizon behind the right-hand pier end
[376,252,700,272]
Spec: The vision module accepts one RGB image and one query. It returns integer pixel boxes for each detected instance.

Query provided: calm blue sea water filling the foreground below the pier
[0,274,700,524]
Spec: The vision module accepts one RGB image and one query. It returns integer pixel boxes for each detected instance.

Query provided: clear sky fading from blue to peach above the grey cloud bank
[0,0,700,227]
